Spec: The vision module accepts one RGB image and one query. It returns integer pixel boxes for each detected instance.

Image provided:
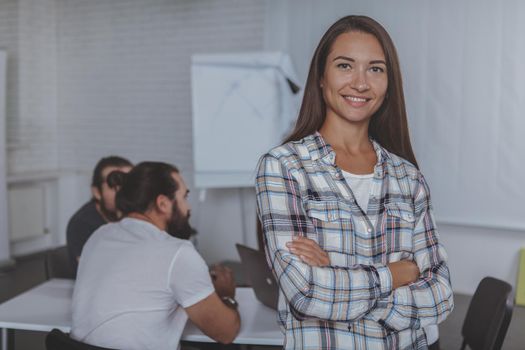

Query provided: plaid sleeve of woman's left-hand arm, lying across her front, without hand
[256,156,392,321]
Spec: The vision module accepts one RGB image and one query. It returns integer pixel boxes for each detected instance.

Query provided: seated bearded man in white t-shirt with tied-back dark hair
[71,162,240,350]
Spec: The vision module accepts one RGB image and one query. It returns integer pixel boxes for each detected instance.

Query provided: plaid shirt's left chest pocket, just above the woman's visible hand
[304,200,353,254]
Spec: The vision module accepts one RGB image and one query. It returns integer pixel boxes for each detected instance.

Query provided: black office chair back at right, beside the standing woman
[461,277,514,350]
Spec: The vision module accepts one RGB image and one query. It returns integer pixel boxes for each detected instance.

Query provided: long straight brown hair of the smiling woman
[284,16,418,167]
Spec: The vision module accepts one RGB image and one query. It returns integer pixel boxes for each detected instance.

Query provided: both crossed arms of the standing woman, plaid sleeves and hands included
[256,156,453,330]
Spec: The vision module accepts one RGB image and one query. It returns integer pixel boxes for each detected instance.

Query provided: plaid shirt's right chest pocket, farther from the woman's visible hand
[383,202,415,254]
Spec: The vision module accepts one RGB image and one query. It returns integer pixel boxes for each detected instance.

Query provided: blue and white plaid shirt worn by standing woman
[256,133,453,350]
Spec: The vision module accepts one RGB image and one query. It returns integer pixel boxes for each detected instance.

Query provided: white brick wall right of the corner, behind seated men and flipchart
[57,0,265,262]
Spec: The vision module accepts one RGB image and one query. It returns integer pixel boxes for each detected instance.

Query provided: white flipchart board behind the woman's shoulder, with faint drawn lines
[191,52,300,188]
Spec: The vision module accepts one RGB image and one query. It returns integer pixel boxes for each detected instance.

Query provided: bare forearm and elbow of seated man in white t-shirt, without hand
[185,293,241,344]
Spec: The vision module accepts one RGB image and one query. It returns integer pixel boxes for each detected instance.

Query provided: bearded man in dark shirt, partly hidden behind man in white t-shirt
[66,156,133,275]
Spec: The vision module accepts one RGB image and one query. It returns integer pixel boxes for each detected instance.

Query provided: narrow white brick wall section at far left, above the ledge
[7,0,58,175]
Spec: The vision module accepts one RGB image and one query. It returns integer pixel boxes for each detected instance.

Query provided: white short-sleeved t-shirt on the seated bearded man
[71,218,214,350]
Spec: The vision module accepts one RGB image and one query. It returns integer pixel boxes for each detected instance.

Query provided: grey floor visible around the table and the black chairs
[0,253,525,350]
